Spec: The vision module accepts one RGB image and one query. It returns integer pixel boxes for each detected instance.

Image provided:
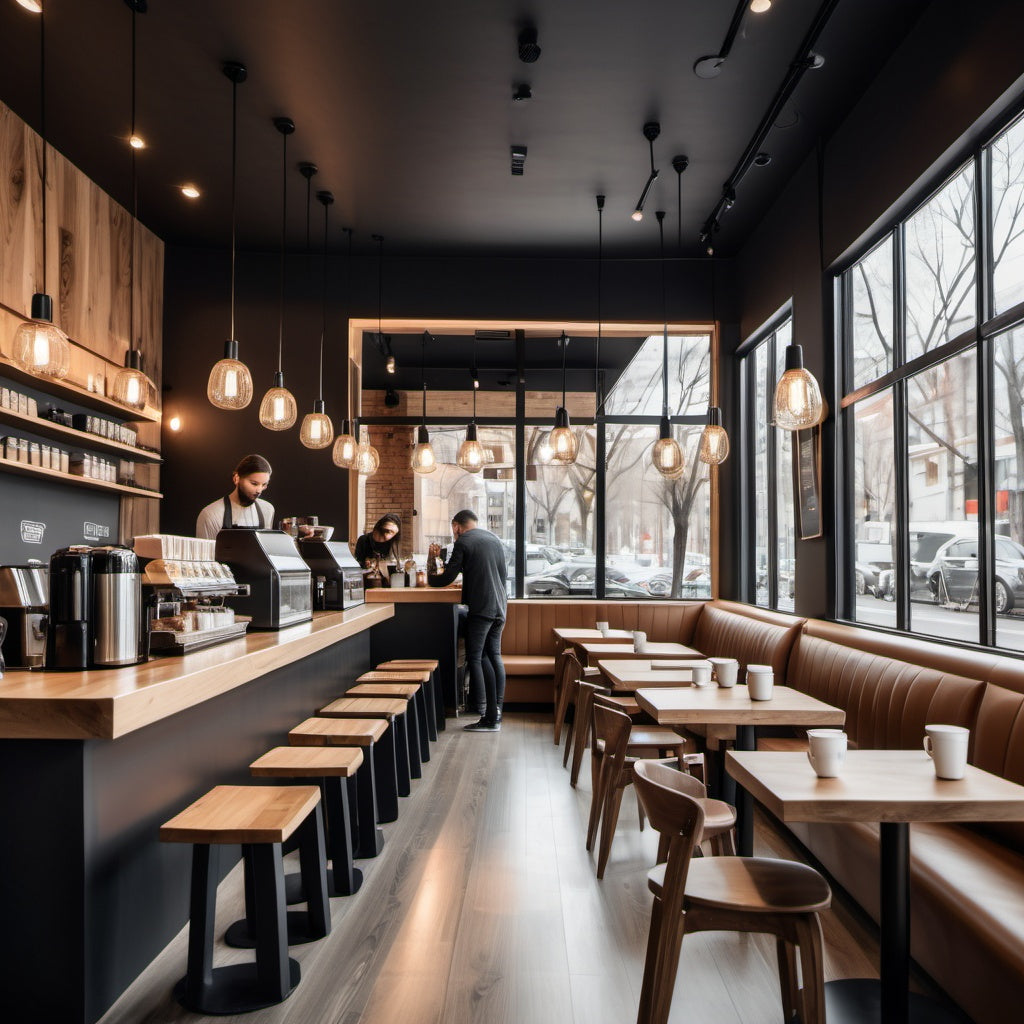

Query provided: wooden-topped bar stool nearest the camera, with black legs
[160,785,331,1015]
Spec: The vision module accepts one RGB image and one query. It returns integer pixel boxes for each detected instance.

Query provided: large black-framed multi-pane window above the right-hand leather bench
[839,108,1024,650]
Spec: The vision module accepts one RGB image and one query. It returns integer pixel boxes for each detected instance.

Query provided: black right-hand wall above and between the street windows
[723,0,1024,616]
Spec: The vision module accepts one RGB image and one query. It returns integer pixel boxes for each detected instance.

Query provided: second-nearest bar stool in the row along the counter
[249,746,362,903]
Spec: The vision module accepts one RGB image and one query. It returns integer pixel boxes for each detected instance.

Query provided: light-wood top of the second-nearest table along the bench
[637,686,843,729]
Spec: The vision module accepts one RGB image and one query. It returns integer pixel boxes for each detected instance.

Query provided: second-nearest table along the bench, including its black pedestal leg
[637,686,846,857]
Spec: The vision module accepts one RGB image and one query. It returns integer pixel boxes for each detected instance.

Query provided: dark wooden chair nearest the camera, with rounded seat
[633,761,831,1024]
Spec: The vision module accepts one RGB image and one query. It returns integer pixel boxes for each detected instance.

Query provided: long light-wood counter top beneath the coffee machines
[0,604,394,739]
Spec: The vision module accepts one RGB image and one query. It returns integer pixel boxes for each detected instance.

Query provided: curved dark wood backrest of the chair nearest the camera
[633,761,703,888]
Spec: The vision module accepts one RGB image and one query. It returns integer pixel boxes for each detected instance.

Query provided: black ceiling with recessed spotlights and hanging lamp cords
[0,0,927,255]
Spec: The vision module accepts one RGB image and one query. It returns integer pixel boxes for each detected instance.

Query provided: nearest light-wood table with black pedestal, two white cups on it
[726,750,1024,1024]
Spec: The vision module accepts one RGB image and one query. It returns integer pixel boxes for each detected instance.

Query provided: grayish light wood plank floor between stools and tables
[102,713,878,1024]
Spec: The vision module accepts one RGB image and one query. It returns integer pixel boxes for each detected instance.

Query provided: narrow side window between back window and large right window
[743,316,797,611]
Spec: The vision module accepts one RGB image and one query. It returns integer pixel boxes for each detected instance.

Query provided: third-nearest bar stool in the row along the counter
[288,718,389,857]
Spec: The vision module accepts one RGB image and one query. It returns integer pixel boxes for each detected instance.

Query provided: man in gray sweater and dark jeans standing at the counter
[428,509,508,732]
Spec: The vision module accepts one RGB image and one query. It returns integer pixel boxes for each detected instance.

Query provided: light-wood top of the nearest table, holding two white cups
[726,750,1024,821]
